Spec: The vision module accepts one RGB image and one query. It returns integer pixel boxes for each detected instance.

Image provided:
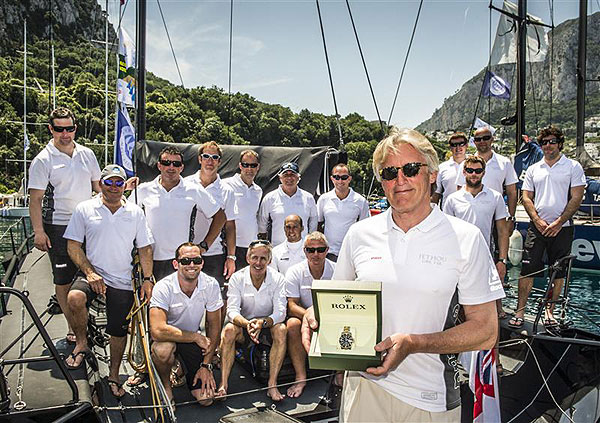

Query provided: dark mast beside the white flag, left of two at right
[515,0,524,152]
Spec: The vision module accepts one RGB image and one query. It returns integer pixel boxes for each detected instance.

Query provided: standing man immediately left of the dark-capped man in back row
[222,150,262,270]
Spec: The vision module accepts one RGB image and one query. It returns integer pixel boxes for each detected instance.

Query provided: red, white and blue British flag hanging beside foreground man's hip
[469,350,501,423]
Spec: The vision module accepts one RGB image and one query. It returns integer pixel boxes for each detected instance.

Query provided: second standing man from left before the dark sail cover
[185,141,236,287]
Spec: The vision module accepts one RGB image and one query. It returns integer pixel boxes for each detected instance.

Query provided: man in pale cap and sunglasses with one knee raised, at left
[64,165,154,397]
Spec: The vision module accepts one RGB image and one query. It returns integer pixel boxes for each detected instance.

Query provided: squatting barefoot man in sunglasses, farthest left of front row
[150,242,223,405]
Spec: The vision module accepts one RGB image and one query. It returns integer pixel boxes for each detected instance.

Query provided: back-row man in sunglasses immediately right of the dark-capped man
[317,163,371,261]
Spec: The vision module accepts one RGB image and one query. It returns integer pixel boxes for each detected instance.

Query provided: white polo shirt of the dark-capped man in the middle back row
[258,185,318,245]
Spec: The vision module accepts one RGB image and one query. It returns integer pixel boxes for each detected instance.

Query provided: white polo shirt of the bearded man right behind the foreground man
[444,185,508,248]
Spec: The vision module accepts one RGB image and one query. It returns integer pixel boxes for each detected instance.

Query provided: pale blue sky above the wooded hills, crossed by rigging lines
[98,0,588,127]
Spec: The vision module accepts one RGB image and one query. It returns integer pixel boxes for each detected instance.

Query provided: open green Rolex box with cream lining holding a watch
[308,280,381,371]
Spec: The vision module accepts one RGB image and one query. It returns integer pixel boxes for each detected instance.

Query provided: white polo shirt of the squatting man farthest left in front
[150,272,223,332]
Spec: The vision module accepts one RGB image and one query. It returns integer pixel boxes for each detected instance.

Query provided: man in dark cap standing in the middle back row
[258,162,318,245]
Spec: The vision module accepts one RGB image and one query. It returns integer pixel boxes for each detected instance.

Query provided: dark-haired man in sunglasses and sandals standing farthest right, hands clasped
[509,126,586,328]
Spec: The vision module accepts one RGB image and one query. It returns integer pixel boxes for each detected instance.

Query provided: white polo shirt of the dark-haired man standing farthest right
[522,154,586,227]
